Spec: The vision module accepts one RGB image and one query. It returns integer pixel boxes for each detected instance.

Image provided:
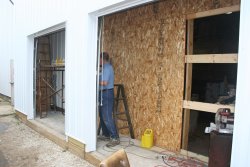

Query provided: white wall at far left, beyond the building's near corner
[0,1,14,97]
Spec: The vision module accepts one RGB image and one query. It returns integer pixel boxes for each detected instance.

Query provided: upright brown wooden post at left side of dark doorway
[182,20,194,150]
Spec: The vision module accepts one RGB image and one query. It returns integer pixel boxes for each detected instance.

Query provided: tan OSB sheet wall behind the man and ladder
[104,0,238,151]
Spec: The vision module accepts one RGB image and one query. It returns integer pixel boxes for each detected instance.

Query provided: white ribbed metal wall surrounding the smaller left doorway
[11,0,127,151]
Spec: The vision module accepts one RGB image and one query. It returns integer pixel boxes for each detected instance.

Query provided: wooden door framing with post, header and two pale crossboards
[182,5,240,150]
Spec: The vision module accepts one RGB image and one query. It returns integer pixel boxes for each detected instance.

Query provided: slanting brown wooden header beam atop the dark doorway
[186,5,240,20]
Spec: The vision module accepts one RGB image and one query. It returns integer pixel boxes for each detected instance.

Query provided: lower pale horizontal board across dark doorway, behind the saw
[183,100,234,113]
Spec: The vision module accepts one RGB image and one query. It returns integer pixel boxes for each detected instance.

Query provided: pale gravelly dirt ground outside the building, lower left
[0,99,92,167]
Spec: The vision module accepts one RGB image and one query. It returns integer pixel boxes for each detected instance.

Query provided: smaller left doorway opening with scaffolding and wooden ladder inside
[34,29,65,135]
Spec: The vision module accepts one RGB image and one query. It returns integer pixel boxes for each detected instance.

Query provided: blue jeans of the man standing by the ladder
[99,89,119,138]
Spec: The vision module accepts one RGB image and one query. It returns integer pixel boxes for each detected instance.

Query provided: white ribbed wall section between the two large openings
[65,1,127,151]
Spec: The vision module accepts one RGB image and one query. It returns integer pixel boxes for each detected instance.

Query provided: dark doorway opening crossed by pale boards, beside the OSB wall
[186,12,240,156]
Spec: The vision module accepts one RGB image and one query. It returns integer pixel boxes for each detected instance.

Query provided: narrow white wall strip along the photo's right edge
[231,0,250,167]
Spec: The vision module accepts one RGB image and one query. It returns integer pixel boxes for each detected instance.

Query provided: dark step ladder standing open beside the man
[114,84,135,139]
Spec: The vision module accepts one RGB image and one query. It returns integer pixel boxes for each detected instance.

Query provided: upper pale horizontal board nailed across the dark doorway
[185,53,238,63]
